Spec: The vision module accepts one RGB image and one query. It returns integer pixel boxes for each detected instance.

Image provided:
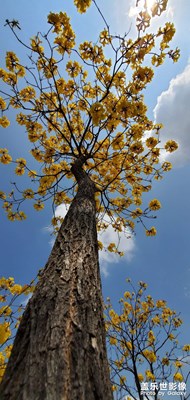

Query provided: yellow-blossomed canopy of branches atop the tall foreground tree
[0,1,179,247]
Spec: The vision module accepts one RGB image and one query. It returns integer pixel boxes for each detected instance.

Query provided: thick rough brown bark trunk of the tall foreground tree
[0,163,113,400]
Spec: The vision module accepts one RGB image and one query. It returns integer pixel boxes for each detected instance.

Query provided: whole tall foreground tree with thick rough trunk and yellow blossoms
[0,0,179,400]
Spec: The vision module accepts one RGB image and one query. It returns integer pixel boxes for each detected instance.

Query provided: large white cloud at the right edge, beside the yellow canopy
[154,65,190,166]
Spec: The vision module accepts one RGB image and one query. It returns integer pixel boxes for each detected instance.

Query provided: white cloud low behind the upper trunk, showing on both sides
[52,204,135,276]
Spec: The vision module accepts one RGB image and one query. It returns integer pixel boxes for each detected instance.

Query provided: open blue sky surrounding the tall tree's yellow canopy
[0,0,190,390]
